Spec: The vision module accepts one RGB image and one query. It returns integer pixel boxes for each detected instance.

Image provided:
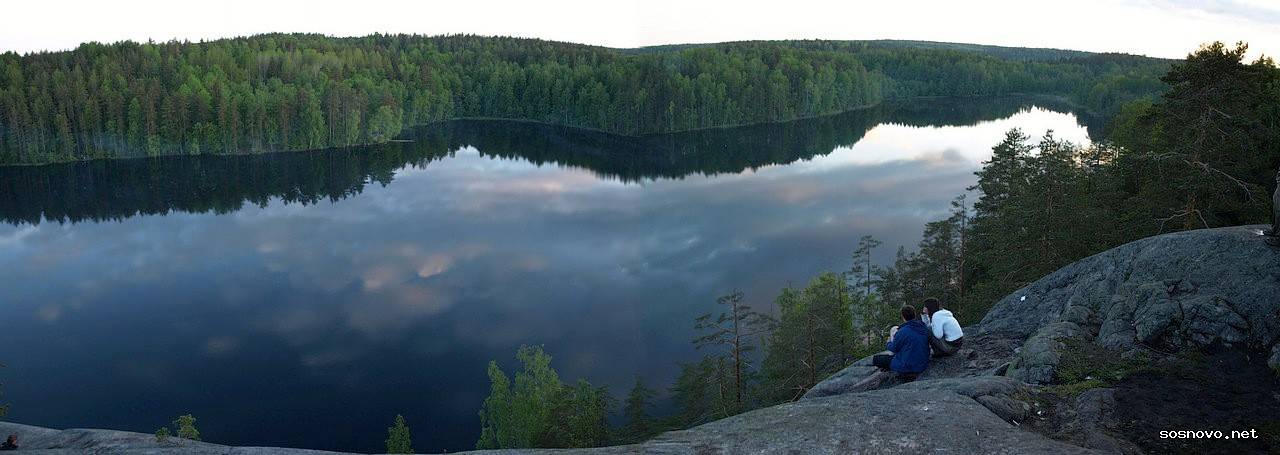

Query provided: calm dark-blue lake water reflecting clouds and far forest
[0,99,1088,451]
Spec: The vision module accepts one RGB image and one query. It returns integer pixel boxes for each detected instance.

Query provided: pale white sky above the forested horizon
[0,0,1280,58]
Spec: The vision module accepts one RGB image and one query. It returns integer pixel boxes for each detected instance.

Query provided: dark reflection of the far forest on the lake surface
[0,96,1101,224]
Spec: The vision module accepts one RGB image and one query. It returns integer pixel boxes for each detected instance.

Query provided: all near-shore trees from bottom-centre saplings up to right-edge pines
[465,44,1280,449]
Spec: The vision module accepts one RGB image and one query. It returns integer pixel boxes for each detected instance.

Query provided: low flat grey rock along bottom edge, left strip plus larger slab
[0,378,1093,455]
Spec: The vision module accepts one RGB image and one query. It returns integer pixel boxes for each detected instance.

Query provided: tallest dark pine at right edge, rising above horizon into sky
[1120,42,1280,233]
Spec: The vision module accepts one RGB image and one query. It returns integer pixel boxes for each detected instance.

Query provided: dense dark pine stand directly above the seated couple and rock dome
[882,44,1280,323]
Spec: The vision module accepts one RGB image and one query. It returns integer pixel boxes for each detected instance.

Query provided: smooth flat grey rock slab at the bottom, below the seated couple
[639,378,1093,454]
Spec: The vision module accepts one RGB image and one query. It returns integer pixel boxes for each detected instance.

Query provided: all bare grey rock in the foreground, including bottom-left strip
[0,226,1280,455]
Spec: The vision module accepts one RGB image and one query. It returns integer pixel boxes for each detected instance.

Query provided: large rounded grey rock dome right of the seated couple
[978,226,1280,383]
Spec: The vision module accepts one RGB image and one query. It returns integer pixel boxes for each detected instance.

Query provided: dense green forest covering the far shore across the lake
[0,35,1169,164]
